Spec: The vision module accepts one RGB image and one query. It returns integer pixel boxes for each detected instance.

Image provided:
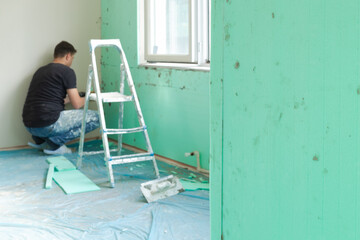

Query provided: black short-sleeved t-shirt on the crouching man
[22,63,76,128]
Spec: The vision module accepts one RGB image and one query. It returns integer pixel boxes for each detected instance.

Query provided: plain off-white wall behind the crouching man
[0,0,101,148]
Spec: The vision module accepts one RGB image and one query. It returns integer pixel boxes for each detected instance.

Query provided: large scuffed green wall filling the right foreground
[211,0,360,240]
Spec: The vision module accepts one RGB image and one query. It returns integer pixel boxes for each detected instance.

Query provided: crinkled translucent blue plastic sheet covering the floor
[0,141,210,240]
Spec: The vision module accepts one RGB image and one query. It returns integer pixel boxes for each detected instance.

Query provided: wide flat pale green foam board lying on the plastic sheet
[53,170,100,194]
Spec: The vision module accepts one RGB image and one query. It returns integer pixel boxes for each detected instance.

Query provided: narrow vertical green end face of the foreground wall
[210,0,224,240]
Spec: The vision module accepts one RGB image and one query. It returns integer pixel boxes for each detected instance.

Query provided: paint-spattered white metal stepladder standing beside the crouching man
[77,39,159,187]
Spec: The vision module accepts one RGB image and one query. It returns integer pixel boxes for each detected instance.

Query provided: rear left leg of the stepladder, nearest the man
[76,64,93,169]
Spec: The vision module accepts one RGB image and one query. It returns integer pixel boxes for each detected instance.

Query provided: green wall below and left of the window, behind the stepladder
[101,0,210,169]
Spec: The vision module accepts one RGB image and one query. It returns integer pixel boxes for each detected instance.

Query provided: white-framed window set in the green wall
[139,0,210,65]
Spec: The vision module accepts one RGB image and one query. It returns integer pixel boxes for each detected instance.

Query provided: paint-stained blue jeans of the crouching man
[26,109,100,149]
